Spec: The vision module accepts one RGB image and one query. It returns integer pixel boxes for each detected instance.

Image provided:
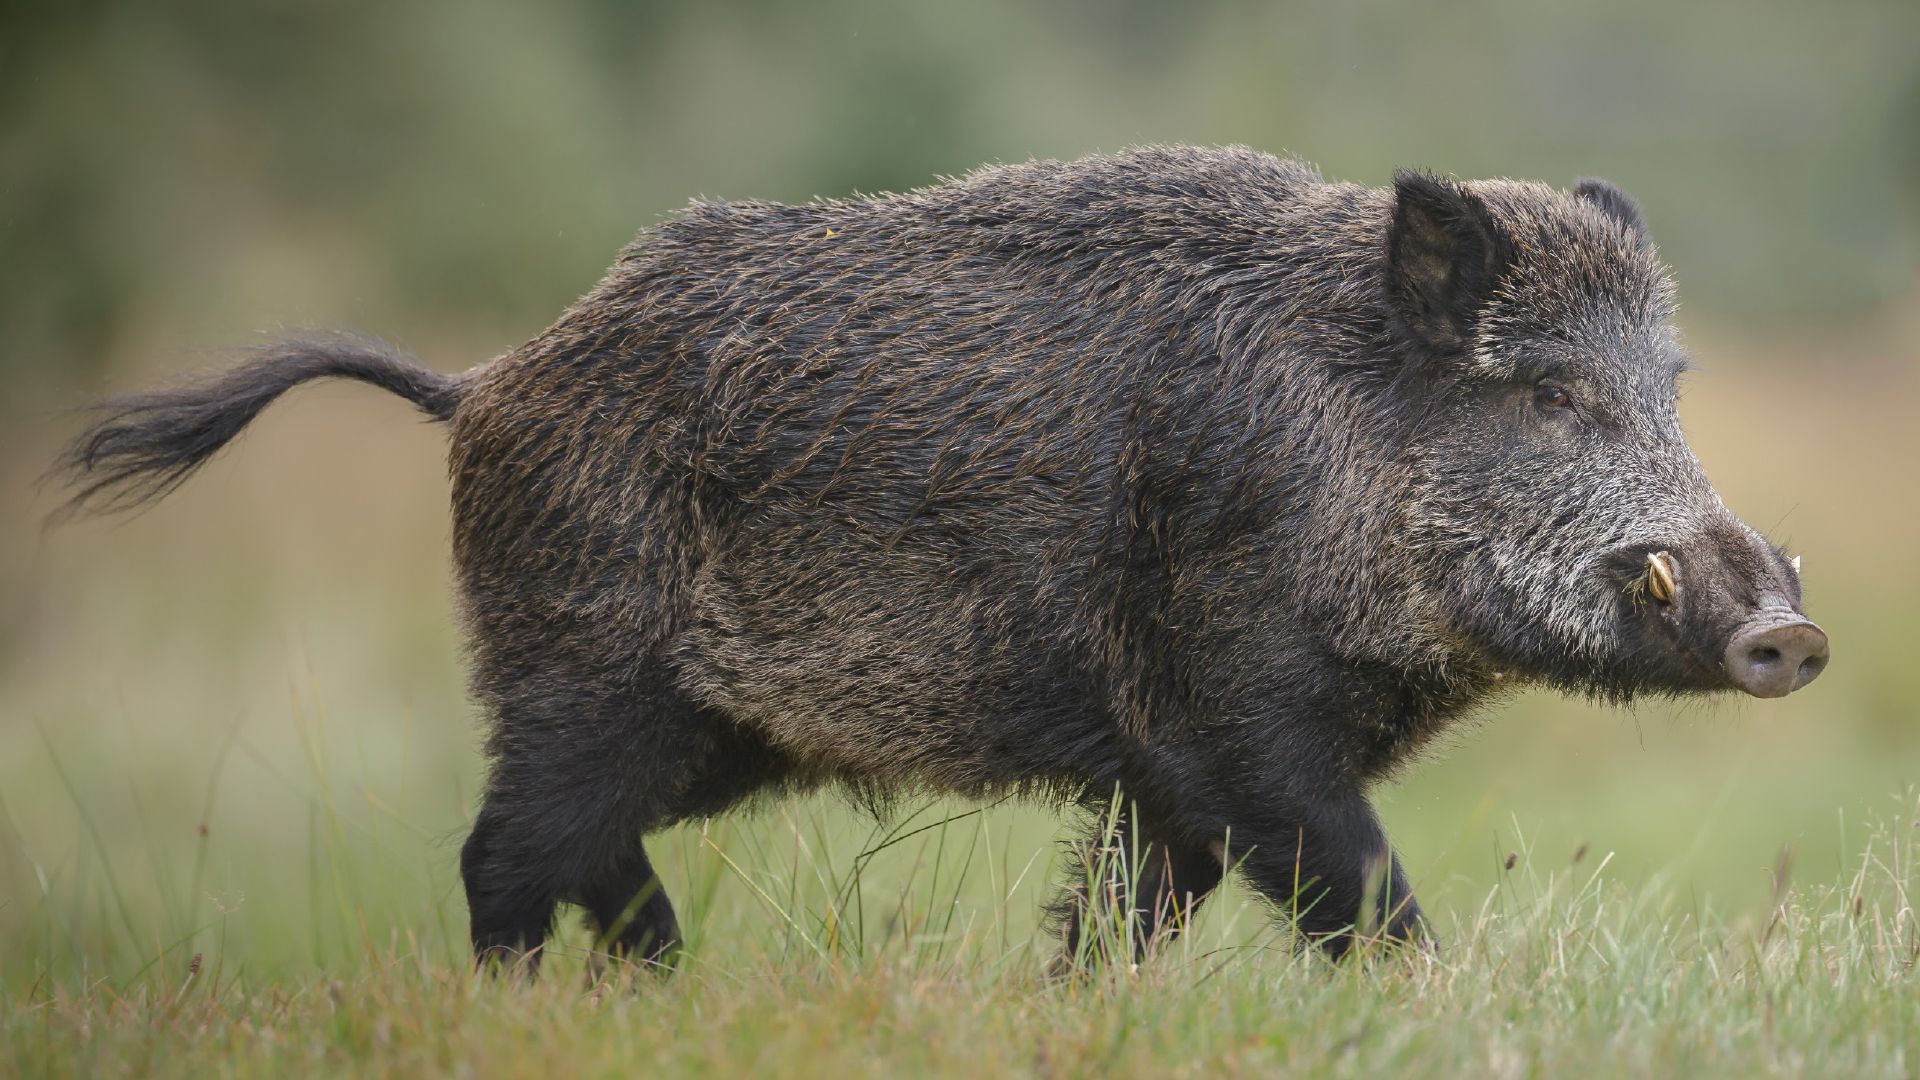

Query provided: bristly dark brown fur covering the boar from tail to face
[48,146,1799,959]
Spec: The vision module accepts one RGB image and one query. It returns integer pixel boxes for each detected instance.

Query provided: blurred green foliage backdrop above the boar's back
[0,0,1920,405]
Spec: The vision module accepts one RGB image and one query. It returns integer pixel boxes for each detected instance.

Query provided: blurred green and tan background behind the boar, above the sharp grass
[0,0,1920,982]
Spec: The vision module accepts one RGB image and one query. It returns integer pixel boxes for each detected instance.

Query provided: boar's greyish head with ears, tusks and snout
[1386,173,1828,700]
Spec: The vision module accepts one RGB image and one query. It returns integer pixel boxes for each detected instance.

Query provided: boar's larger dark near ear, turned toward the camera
[1386,171,1513,354]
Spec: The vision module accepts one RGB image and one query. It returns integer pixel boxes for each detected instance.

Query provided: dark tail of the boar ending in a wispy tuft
[46,334,465,519]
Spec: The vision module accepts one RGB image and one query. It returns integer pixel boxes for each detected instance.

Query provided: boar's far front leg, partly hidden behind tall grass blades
[1054,799,1221,970]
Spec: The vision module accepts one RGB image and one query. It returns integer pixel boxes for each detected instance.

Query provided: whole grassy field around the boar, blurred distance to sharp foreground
[0,304,1920,1076]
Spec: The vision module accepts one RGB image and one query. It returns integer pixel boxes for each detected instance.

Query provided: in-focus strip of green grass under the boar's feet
[0,745,1920,1078]
